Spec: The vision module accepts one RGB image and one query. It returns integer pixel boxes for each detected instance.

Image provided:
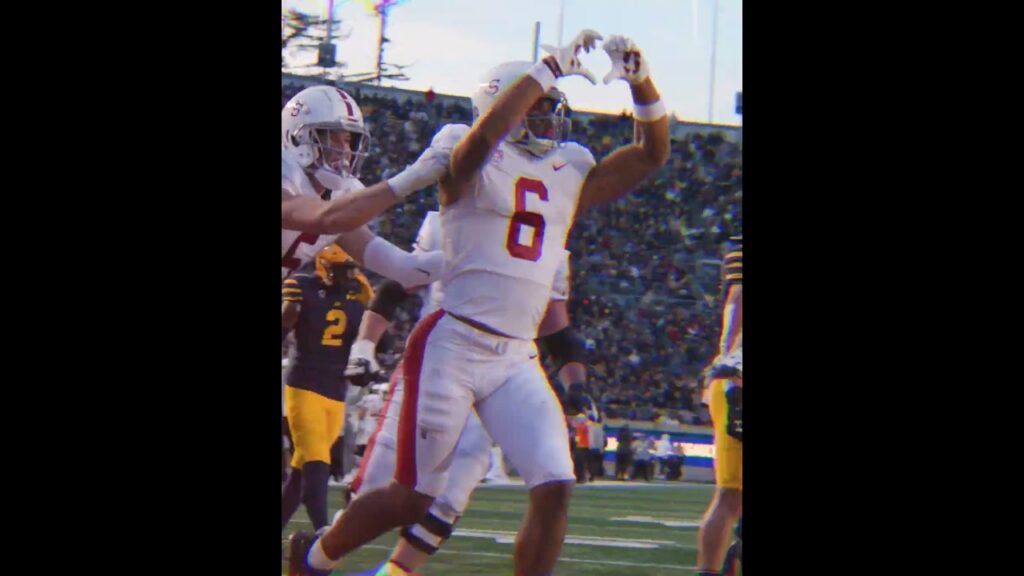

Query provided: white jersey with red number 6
[430,124,595,339]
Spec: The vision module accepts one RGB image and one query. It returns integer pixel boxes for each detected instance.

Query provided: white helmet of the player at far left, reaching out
[281,86,370,190]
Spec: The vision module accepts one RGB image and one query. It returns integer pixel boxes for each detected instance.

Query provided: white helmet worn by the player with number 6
[470,61,569,157]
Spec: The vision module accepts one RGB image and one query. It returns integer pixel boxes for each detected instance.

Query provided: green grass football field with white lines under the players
[282,482,713,576]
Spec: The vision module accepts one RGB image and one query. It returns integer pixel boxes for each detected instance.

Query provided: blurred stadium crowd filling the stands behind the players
[282,84,742,424]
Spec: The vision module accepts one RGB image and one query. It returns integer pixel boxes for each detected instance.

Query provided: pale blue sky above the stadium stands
[282,0,742,124]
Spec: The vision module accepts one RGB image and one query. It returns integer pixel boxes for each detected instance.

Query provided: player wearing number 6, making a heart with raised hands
[302,31,669,576]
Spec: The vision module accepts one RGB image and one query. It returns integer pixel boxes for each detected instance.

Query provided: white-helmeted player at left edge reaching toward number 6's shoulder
[281,86,450,286]
